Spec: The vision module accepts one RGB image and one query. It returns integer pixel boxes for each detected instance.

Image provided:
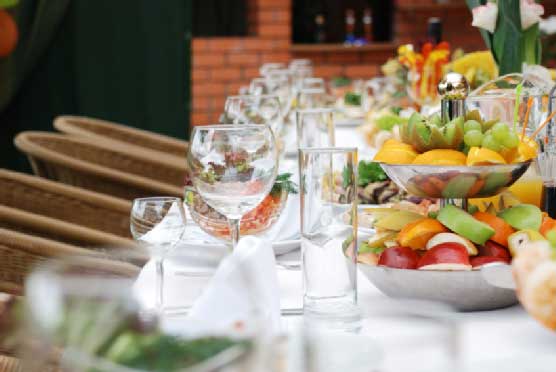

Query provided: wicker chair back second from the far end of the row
[14,132,186,199]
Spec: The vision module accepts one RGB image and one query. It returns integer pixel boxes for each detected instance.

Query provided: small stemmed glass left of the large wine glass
[130,196,186,312]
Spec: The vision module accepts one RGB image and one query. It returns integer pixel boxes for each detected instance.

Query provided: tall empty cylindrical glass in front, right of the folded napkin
[299,148,360,329]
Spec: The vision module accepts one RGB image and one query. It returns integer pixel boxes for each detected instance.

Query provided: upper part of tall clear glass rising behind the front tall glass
[296,108,335,148]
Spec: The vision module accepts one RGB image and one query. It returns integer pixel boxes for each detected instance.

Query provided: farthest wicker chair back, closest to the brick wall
[54,116,189,161]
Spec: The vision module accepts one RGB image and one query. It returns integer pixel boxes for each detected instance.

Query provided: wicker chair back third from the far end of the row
[0,169,131,238]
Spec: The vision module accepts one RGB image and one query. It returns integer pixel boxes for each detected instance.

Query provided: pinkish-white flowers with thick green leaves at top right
[466,0,544,75]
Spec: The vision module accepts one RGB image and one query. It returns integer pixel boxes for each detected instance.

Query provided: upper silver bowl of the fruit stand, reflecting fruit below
[380,161,531,199]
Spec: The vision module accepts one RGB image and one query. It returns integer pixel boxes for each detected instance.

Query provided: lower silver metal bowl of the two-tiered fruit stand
[357,263,517,311]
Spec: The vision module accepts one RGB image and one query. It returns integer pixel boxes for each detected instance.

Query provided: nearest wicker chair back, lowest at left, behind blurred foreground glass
[0,228,140,295]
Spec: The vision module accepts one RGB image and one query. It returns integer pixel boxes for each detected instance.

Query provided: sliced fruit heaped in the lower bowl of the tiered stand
[360,204,556,271]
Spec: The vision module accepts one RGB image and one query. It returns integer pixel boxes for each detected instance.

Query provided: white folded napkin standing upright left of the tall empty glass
[188,236,281,333]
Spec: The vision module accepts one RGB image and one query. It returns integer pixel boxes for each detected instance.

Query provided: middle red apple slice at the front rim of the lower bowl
[417,243,471,271]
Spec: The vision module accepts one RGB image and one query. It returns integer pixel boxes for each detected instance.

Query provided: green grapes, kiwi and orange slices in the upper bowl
[375,110,538,166]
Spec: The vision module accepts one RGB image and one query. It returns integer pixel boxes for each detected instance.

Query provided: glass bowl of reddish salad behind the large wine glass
[184,186,288,241]
